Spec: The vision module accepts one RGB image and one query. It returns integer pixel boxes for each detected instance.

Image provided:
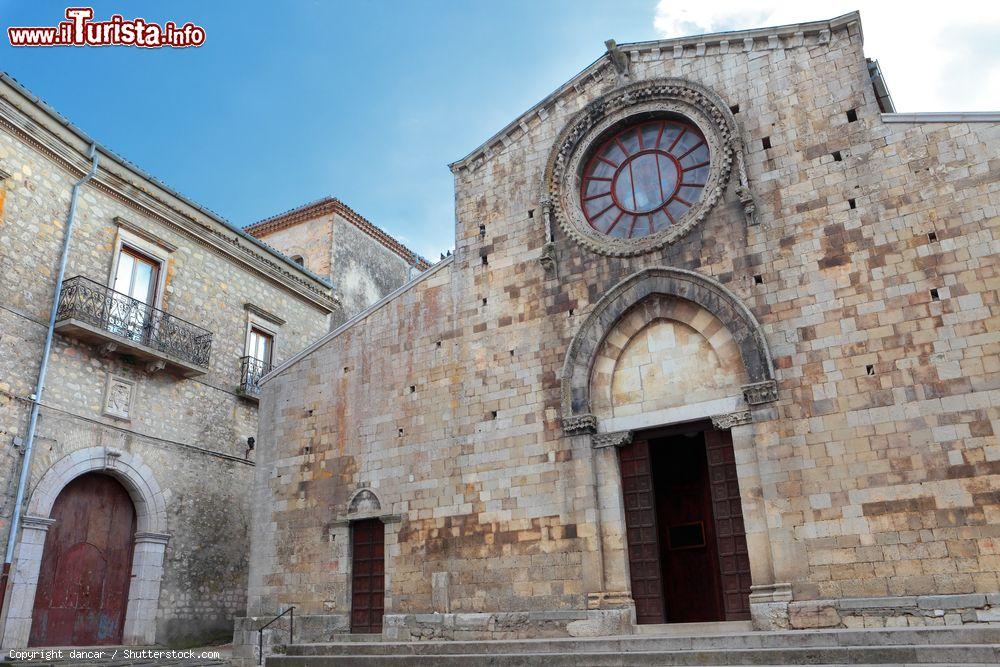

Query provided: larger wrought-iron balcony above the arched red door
[56,276,212,377]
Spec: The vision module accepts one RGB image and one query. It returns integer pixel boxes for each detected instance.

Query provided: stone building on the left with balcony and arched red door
[0,70,422,648]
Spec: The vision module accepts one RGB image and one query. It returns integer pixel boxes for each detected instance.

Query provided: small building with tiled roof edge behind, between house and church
[246,197,430,328]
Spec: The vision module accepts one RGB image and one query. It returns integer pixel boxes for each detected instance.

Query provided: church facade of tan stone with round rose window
[242,13,1000,656]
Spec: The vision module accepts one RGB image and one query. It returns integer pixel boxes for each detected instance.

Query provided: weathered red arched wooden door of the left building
[28,473,135,646]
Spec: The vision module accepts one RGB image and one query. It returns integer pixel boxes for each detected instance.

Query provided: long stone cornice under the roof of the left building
[0,73,338,313]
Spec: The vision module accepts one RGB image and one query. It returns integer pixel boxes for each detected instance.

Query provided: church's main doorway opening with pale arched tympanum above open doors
[590,294,751,624]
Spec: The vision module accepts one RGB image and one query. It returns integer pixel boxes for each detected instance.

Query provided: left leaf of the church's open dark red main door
[618,440,664,623]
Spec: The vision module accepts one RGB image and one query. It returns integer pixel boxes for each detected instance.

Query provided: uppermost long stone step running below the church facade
[286,625,1000,656]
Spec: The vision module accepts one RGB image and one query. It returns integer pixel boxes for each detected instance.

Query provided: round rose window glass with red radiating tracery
[580,120,710,238]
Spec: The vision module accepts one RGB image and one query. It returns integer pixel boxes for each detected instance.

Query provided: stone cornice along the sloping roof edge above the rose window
[448,12,862,174]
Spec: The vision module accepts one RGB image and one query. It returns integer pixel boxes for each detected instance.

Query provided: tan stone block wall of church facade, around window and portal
[248,13,1000,636]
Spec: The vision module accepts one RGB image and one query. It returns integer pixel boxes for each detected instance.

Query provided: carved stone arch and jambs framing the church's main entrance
[562,267,790,626]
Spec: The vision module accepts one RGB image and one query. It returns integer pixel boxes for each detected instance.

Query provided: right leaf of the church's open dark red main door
[705,430,750,621]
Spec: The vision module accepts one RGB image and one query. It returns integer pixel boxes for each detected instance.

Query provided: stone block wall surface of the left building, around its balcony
[0,77,333,644]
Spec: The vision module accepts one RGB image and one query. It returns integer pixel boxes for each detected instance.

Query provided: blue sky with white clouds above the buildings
[0,0,1000,259]
